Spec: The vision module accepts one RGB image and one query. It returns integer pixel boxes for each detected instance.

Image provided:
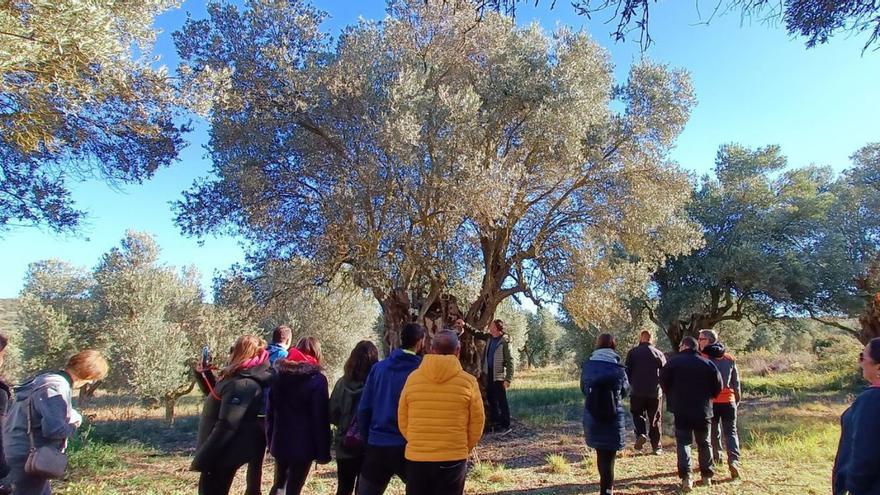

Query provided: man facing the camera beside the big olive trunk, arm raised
[483,320,513,435]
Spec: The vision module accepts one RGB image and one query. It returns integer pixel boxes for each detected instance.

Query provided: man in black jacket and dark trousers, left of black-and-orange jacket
[660,337,721,492]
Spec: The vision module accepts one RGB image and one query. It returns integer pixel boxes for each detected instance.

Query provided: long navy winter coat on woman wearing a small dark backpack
[581,349,629,450]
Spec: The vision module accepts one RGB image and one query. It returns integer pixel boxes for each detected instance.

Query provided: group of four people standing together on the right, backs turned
[581,330,742,495]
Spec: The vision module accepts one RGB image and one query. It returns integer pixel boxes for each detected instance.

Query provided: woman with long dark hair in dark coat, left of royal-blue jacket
[330,340,379,495]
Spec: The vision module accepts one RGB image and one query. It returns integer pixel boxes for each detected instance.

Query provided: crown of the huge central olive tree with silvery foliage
[176,0,697,372]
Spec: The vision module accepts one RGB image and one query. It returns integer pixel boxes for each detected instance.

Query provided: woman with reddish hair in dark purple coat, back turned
[267,337,331,495]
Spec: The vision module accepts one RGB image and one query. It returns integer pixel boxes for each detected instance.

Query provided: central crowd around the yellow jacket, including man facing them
[192,320,513,495]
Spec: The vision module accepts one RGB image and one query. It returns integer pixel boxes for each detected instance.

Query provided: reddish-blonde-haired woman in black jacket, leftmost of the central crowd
[192,335,274,495]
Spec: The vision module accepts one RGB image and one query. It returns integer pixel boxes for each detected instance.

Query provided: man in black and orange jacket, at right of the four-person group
[699,330,742,479]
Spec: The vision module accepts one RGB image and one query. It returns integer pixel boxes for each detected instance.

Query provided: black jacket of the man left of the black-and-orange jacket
[660,350,721,428]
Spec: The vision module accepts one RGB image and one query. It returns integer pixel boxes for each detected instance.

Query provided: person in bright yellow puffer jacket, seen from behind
[397,330,486,495]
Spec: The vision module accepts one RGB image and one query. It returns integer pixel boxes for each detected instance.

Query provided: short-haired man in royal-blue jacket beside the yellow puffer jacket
[357,323,425,495]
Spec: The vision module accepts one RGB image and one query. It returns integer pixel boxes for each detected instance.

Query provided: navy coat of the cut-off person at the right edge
[832,387,880,495]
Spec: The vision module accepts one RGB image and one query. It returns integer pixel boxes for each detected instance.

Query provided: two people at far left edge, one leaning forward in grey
[0,335,109,495]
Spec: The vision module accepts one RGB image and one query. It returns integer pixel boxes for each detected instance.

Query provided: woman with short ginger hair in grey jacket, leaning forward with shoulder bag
[3,350,108,495]
